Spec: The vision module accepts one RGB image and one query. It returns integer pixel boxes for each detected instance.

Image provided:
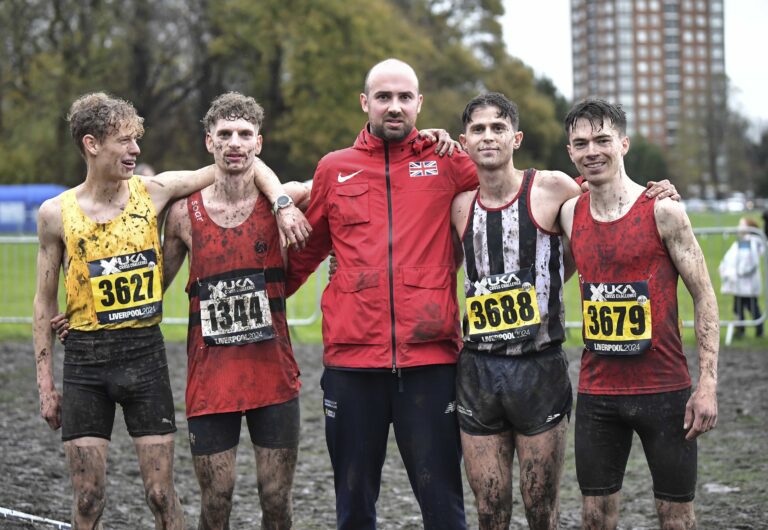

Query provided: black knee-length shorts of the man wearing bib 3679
[575,388,697,502]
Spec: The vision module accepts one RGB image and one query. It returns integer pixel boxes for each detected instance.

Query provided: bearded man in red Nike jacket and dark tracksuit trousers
[287,59,477,530]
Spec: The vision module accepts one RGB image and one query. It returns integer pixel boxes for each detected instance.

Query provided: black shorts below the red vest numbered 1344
[187,398,299,455]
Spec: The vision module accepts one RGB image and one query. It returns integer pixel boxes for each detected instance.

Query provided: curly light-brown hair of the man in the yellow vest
[67,92,144,157]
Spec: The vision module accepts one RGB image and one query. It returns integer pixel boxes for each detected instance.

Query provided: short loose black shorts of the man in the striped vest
[456,347,573,436]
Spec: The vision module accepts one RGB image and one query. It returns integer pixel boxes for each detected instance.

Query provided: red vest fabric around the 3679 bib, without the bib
[571,193,691,395]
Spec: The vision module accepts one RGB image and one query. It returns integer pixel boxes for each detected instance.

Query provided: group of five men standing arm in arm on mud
[34,59,719,529]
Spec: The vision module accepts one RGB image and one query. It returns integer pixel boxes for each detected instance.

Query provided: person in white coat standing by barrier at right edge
[718,217,765,338]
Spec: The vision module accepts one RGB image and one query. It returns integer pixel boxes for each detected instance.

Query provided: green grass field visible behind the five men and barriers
[0,208,765,346]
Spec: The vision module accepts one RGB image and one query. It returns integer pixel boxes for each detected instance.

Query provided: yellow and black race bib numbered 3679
[581,281,651,355]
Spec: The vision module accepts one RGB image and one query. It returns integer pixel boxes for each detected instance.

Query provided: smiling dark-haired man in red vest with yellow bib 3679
[561,99,720,529]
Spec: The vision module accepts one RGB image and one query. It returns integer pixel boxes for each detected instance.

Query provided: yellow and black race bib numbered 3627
[88,249,163,324]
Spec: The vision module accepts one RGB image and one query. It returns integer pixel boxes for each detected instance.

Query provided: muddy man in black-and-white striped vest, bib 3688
[451,93,580,529]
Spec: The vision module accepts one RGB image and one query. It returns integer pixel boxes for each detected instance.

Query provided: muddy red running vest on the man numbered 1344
[186,192,301,417]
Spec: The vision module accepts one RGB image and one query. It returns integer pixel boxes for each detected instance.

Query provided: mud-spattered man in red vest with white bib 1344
[163,93,309,529]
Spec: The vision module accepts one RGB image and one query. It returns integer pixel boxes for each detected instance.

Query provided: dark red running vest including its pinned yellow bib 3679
[571,193,691,395]
